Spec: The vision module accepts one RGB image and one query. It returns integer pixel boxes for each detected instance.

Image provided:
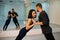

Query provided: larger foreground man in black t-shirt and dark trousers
[36,3,55,40]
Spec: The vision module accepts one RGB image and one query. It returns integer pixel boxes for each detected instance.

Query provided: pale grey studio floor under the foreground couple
[0,32,60,40]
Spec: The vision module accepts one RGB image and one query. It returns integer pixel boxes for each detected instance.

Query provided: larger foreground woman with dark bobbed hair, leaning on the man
[15,9,36,40]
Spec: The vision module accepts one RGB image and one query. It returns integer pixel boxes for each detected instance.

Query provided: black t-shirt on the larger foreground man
[39,11,49,26]
